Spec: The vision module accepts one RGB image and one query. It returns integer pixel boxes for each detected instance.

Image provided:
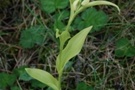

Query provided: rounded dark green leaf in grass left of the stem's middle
[19,25,45,48]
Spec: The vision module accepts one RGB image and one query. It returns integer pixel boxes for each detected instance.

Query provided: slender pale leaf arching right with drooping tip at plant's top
[82,0,120,13]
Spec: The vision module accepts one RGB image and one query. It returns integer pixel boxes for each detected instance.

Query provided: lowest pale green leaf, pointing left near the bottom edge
[25,68,59,90]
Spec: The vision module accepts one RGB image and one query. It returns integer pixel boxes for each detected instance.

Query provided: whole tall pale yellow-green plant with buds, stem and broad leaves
[26,0,120,90]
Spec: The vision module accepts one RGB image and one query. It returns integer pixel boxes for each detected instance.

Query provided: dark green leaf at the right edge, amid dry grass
[115,38,135,57]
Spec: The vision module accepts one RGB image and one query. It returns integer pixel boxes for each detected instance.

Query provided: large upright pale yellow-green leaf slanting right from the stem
[56,26,92,73]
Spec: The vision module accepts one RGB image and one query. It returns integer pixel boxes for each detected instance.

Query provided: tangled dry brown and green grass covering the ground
[0,0,135,90]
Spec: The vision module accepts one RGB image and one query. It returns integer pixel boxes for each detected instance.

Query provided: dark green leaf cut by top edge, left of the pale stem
[40,0,68,13]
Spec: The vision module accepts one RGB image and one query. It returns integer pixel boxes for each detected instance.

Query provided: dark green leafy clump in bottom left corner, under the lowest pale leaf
[0,66,47,90]
